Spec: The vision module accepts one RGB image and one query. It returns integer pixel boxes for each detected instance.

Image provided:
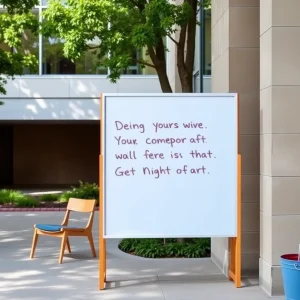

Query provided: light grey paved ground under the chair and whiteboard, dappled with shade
[0,212,284,300]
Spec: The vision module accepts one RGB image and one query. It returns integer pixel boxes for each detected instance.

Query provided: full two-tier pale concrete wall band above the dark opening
[0,76,161,121]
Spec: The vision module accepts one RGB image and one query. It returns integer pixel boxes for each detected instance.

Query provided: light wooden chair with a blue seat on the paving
[30,198,96,264]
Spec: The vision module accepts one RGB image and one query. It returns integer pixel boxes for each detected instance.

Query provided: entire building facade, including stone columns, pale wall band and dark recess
[0,0,300,295]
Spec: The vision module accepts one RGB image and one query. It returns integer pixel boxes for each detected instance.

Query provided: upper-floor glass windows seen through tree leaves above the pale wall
[0,0,156,75]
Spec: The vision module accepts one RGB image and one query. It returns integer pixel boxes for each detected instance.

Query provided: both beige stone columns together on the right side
[212,0,300,295]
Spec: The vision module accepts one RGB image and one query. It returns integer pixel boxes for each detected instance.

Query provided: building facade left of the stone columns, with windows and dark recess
[0,0,210,187]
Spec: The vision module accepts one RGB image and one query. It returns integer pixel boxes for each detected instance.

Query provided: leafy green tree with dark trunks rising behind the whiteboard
[42,0,210,92]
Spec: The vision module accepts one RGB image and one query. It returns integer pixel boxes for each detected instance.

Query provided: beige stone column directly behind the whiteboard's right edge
[212,0,260,274]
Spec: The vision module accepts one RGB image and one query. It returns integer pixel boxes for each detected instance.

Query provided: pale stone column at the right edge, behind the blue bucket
[259,0,300,295]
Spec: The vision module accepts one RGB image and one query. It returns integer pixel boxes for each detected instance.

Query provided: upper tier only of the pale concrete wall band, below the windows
[0,75,161,99]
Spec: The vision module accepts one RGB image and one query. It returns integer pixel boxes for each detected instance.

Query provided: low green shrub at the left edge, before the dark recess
[0,189,38,207]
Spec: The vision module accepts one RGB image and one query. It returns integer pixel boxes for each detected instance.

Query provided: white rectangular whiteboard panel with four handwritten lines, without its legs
[100,94,238,238]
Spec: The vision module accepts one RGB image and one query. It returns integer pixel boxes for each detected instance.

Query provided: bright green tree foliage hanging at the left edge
[0,0,39,104]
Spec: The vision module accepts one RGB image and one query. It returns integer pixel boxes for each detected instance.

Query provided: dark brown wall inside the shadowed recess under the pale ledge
[14,122,100,185]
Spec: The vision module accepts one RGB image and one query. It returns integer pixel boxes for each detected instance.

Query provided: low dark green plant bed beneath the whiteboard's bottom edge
[119,238,210,258]
